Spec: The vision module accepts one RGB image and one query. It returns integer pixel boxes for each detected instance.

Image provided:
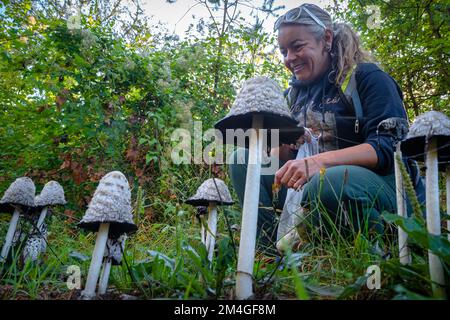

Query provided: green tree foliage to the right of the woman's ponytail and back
[333,0,450,118]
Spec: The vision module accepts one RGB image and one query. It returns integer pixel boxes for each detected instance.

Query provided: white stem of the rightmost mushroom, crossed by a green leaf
[426,138,445,297]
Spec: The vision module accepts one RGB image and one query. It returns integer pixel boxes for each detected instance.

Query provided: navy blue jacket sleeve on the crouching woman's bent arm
[356,67,407,175]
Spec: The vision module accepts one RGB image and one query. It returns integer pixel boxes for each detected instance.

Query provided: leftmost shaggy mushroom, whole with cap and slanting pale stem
[0,177,36,261]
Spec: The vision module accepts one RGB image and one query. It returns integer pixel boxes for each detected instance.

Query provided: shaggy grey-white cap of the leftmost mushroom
[0,177,36,213]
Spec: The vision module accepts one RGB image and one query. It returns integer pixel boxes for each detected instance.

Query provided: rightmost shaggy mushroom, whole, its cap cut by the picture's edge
[401,111,450,297]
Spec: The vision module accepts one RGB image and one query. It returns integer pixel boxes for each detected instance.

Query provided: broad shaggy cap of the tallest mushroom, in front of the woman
[214,77,304,146]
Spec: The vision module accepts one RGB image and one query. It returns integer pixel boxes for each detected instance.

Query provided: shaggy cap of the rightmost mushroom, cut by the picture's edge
[401,111,450,170]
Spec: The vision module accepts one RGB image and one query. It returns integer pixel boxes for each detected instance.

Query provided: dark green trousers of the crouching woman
[229,148,396,251]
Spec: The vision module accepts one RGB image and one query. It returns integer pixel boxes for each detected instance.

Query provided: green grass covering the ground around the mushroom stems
[0,170,449,300]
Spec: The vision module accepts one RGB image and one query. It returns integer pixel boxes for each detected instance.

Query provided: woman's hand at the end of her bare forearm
[275,156,324,189]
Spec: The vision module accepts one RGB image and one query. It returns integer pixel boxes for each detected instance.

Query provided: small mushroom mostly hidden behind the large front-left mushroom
[98,234,127,294]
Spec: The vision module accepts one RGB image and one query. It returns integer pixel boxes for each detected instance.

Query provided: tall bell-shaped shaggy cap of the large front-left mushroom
[78,171,137,238]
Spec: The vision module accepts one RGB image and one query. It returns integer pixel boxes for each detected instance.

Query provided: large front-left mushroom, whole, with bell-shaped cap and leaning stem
[78,171,137,299]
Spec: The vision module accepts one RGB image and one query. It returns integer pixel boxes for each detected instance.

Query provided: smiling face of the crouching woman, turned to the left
[278,24,332,83]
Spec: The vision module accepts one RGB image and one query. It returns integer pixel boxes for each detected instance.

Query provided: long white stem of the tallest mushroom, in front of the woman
[236,115,263,299]
